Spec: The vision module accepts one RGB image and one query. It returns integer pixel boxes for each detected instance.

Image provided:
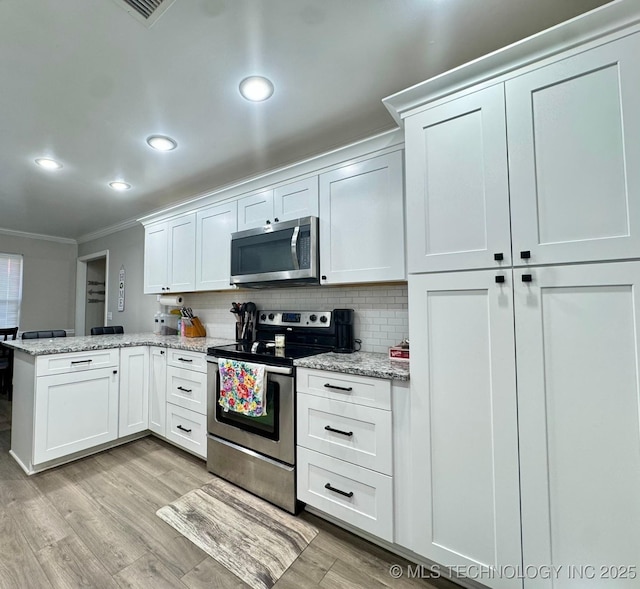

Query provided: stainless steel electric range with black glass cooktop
[207,309,352,513]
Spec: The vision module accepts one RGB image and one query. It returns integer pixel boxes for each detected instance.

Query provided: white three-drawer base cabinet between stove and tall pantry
[297,368,394,542]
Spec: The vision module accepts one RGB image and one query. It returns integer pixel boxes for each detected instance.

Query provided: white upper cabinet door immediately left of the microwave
[196,201,238,290]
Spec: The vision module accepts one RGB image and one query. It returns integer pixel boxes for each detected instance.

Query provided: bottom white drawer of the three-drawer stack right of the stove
[297,446,393,542]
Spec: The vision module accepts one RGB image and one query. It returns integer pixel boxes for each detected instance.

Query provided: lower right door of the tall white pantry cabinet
[512,262,640,589]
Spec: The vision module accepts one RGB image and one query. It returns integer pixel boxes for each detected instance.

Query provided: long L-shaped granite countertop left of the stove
[2,333,235,356]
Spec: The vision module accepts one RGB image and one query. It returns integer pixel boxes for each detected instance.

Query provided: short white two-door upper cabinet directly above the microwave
[238,176,318,231]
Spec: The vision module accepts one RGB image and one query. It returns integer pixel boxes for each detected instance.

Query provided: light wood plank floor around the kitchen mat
[0,397,457,589]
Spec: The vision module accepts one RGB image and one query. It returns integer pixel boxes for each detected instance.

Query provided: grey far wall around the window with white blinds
[0,232,78,331]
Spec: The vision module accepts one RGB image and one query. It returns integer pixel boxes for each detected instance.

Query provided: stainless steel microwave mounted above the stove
[231,217,320,288]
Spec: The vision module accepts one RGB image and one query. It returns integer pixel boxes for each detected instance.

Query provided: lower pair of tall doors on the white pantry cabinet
[409,261,640,589]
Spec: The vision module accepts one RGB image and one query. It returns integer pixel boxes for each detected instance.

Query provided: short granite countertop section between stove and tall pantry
[294,352,409,380]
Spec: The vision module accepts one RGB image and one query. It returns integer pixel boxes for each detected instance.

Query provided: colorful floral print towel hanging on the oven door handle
[218,358,267,417]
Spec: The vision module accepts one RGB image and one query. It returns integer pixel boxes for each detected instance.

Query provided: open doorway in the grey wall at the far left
[76,250,109,335]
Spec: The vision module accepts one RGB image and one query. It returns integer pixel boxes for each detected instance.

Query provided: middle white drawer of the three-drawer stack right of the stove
[297,394,392,475]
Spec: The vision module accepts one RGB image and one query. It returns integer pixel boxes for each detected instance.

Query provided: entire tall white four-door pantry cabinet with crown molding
[387,5,640,589]
